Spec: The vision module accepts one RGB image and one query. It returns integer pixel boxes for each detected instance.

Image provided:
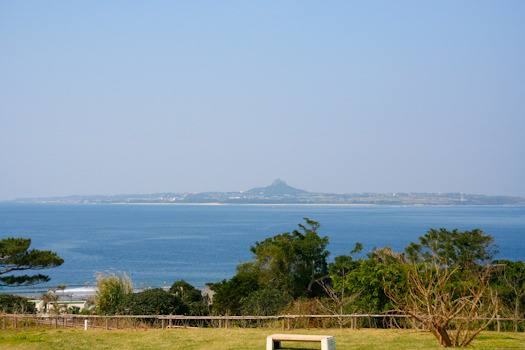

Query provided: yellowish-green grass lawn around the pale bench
[0,328,525,350]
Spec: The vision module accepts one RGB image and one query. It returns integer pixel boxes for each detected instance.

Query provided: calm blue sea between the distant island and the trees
[0,203,525,294]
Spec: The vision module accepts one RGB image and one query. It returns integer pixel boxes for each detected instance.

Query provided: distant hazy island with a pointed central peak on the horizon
[9,179,525,205]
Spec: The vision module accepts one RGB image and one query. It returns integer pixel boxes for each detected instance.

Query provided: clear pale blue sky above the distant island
[0,0,525,200]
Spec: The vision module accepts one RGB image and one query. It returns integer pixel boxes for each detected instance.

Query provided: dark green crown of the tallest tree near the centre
[250,218,330,297]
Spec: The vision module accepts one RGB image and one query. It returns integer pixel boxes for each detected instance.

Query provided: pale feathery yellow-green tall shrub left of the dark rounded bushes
[95,272,133,315]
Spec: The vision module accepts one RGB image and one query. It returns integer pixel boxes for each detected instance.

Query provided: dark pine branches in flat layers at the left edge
[0,238,64,287]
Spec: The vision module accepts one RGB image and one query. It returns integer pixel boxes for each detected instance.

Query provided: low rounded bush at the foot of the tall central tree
[240,288,293,316]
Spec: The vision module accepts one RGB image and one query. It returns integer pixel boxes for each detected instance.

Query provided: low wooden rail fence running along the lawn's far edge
[4,314,525,331]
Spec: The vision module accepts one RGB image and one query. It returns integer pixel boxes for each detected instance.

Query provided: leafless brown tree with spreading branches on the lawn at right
[385,258,498,347]
